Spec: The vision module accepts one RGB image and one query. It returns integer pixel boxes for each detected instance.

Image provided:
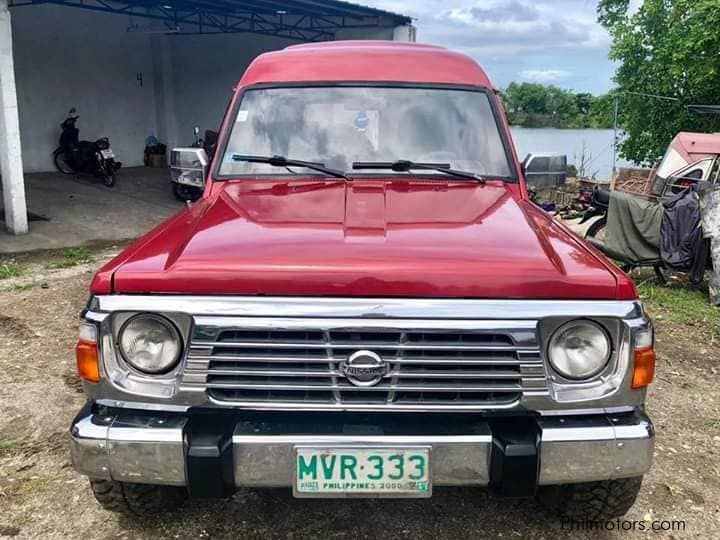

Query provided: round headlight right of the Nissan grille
[548,320,612,379]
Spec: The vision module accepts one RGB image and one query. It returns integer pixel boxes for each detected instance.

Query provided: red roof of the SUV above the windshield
[240,41,492,88]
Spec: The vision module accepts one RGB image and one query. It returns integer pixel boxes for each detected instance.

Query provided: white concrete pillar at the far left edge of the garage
[0,0,28,234]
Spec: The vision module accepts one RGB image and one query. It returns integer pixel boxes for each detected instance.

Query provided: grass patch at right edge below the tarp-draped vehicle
[638,281,720,336]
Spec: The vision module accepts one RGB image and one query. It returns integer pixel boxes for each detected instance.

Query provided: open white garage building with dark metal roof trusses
[0,0,415,234]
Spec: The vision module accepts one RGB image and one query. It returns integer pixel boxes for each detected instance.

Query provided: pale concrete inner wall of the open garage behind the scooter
[12,6,296,172]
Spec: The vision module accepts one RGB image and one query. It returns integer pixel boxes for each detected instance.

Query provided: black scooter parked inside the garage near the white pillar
[53,107,122,187]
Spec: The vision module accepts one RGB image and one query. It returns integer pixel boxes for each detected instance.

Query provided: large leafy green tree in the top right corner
[598,0,720,163]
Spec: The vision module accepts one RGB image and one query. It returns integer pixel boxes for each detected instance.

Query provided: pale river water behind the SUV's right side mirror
[511,126,631,180]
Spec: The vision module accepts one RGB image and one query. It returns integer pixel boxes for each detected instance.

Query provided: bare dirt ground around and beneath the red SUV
[0,250,720,540]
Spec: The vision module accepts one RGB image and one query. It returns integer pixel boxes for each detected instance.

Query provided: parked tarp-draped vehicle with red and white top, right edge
[583,132,720,283]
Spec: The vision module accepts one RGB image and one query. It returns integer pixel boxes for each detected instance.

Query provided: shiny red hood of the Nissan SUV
[93,179,634,299]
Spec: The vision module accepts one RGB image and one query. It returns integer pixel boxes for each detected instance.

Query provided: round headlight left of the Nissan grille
[118,314,182,375]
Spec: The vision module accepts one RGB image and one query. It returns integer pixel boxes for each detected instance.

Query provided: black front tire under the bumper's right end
[536,476,642,521]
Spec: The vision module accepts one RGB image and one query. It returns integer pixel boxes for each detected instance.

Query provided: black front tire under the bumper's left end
[90,478,187,517]
